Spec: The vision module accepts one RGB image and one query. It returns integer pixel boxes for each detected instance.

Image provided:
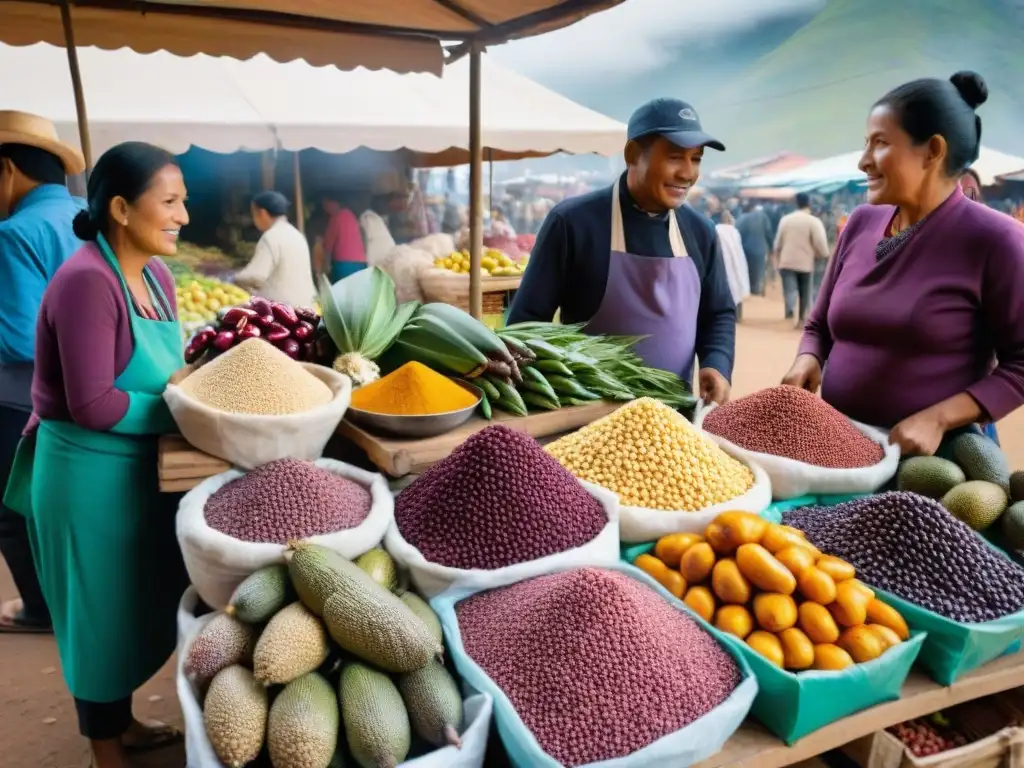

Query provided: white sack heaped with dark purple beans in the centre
[384,425,620,597]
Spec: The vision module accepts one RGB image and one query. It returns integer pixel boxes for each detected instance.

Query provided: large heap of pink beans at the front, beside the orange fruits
[455,567,740,766]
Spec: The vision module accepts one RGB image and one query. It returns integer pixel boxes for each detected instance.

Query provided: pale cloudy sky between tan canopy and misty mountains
[490,0,825,82]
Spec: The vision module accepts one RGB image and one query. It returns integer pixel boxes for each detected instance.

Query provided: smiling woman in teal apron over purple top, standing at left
[5,142,188,768]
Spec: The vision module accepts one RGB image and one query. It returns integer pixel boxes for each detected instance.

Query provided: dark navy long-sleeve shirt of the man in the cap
[509,176,736,379]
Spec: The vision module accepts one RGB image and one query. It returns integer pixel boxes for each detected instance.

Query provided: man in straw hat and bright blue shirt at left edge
[0,112,85,633]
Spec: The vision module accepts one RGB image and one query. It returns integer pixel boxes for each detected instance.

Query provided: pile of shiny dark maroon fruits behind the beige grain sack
[185,296,321,364]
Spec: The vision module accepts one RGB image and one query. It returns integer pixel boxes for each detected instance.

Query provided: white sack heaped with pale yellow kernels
[546,397,771,543]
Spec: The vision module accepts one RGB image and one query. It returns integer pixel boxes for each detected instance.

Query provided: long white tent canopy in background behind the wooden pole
[0,43,626,162]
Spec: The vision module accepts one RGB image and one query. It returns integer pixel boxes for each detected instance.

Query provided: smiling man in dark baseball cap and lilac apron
[508,98,736,403]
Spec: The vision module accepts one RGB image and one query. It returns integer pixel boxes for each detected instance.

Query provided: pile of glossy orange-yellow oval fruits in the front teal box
[634,512,910,672]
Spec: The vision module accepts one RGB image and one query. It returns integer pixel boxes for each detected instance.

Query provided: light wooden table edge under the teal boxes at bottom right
[695,651,1024,768]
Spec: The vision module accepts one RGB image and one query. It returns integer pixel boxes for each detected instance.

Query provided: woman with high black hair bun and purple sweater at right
[783,72,1024,455]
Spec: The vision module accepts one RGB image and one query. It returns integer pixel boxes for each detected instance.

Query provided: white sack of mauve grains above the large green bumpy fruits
[175,459,394,610]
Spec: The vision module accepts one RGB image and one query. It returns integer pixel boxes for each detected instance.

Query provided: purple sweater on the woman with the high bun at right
[800,187,1024,428]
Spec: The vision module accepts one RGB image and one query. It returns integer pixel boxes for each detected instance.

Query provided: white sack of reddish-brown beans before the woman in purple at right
[694,385,900,500]
